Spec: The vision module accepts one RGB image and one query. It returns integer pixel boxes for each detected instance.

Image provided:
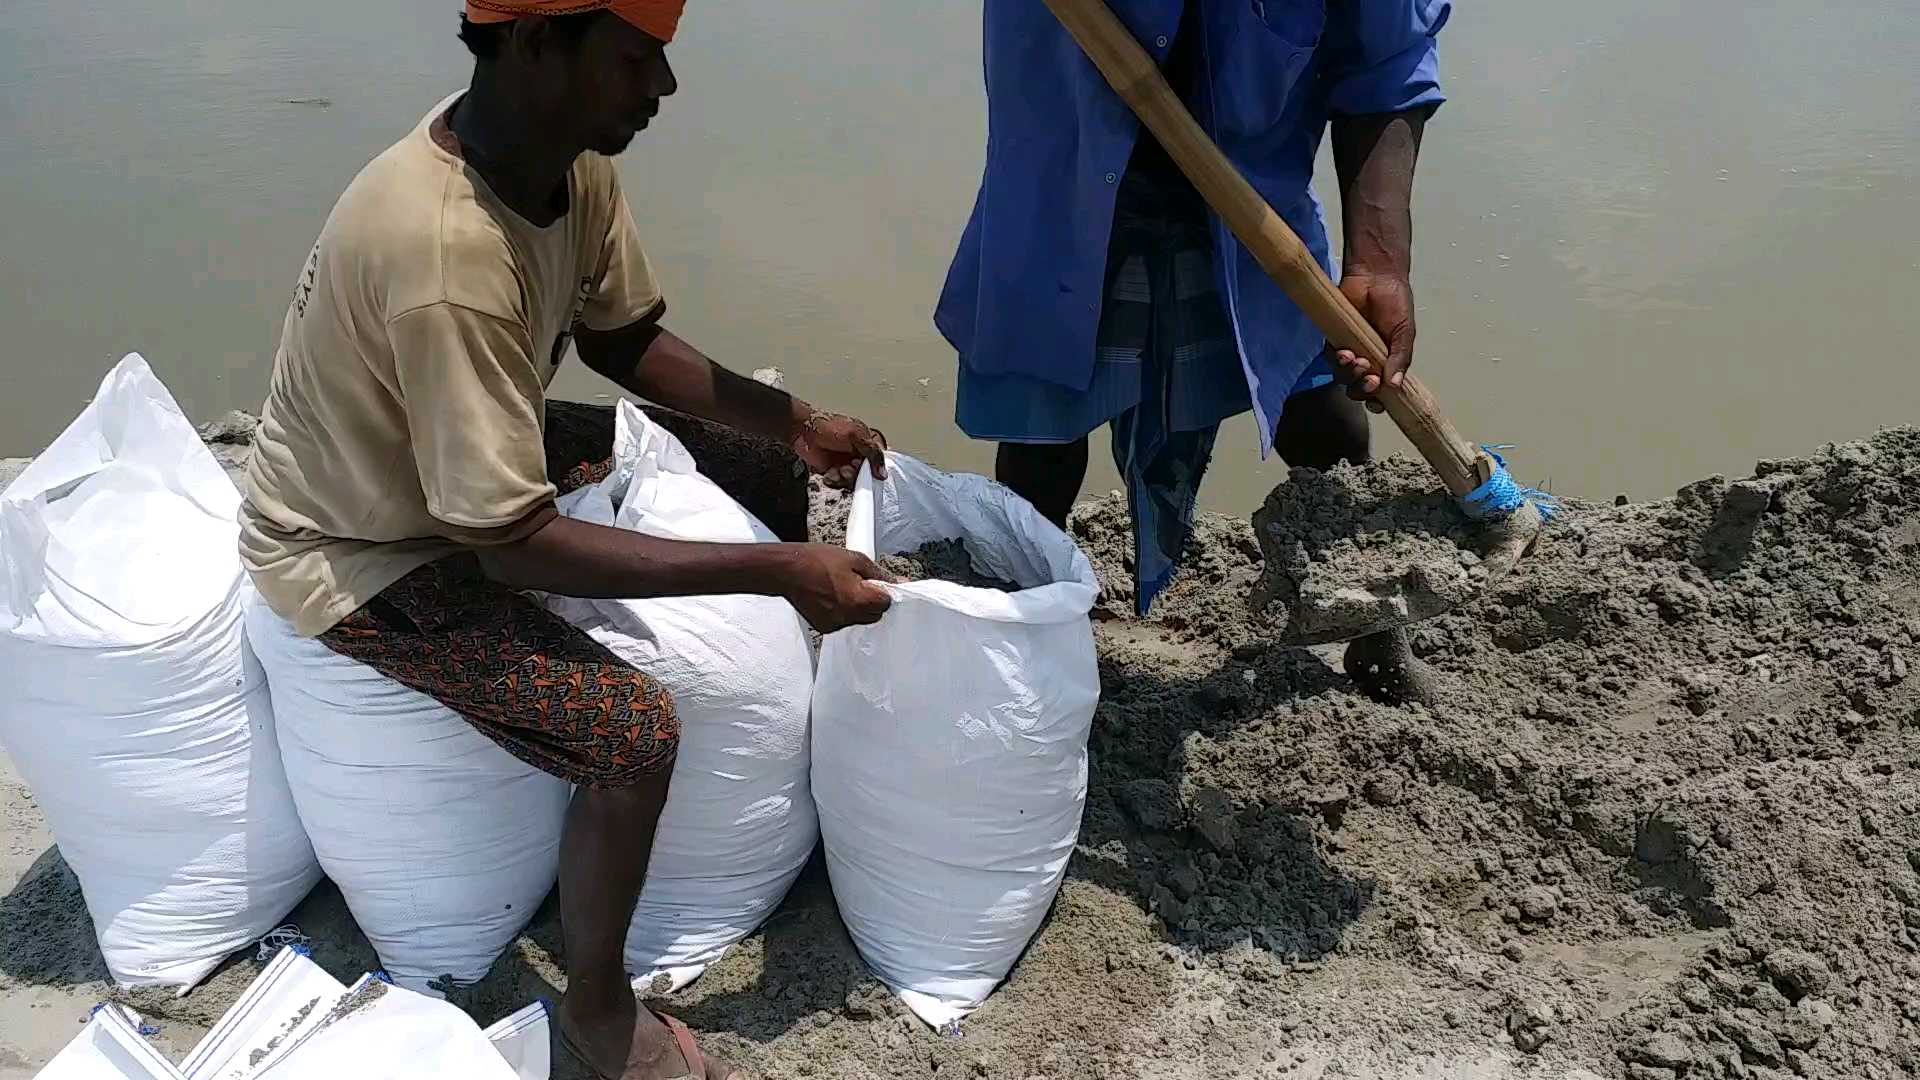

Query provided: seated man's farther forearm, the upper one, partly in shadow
[578,319,812,444]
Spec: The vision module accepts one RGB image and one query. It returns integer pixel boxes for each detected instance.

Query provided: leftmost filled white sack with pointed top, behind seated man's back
[0,356,321,992]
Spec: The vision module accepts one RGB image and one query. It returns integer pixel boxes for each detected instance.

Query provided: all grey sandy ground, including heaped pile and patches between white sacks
[0,429,1920,1080]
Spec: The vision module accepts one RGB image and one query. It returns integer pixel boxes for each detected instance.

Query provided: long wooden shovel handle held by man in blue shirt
[1046,0,1494,496]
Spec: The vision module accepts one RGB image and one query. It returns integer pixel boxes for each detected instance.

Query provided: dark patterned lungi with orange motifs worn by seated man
[321,413,680,788]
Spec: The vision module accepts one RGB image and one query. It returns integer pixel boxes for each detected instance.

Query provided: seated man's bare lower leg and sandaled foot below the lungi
[559,761,728,1080]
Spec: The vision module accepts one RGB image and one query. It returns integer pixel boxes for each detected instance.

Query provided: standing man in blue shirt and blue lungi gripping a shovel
[935,0,1452,698]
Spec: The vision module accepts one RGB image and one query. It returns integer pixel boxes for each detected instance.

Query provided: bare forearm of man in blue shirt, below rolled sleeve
[1332,108,1430,277]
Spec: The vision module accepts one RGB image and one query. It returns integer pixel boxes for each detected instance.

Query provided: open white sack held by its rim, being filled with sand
[814,454,1100,1026]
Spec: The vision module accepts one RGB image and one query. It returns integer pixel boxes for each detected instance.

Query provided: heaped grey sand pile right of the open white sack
[1077,429,1920,1080]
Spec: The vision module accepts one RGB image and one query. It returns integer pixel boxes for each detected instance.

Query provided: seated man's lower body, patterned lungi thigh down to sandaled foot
[321,468,728,1080]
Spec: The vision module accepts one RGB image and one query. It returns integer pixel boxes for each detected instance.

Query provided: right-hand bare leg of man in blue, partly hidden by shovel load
[1273,386,1434,701]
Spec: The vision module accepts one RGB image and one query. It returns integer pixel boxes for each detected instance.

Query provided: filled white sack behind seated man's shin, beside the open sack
[547,402,820,990]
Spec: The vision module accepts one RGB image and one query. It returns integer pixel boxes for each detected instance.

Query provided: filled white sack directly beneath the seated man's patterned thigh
[246,600,572,992]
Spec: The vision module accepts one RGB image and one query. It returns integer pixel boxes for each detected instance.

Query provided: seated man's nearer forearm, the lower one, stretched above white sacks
[474,517,793,600]
